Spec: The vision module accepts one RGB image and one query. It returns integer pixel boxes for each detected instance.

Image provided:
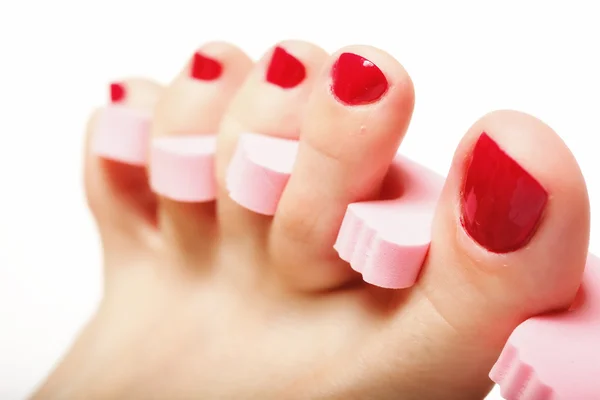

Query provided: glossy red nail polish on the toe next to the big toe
[331,53,388,106]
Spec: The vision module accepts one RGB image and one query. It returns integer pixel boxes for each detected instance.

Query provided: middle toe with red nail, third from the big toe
[217,40,327,240]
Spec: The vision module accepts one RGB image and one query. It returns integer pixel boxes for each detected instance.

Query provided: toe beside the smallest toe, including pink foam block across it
[150,42,252,253]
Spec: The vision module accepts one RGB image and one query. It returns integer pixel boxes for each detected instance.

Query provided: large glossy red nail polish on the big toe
[461,132,548,253]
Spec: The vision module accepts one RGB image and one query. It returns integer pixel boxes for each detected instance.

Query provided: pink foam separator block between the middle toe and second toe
[226,133,298,215]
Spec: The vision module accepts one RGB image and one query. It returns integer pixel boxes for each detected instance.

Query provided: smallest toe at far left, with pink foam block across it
[85,79,162,246]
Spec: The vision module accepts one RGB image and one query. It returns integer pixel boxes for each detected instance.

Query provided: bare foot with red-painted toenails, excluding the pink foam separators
[34,41,589,399]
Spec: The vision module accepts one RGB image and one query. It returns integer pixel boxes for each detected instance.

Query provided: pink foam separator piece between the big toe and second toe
[334,156,443,289]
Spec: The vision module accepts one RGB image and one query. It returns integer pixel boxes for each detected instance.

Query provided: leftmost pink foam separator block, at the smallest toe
[92,106,151,165]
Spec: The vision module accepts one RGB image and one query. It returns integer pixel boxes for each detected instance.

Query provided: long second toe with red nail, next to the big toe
[270,46,414,289]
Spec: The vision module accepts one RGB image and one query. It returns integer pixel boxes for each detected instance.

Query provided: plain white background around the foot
[0,0,600,400]
